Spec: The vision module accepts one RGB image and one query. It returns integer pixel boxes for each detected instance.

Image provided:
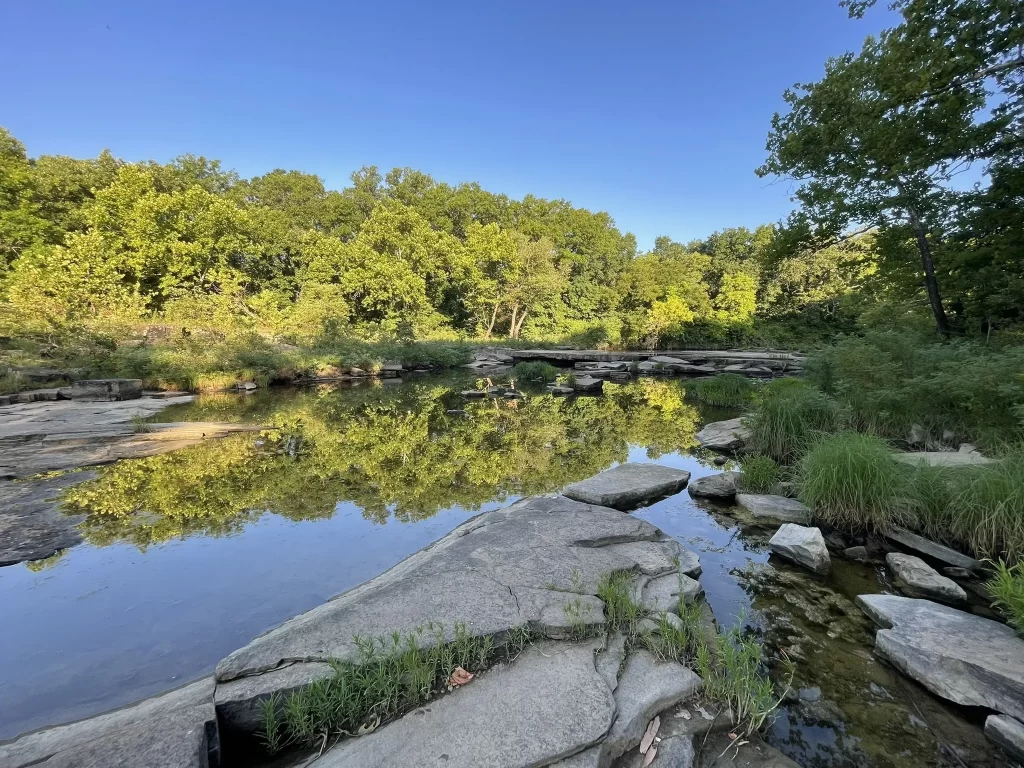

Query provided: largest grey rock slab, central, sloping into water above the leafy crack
[216,497,679,728]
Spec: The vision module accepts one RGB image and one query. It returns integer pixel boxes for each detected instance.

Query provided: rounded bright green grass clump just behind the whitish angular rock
[798,432,905,530]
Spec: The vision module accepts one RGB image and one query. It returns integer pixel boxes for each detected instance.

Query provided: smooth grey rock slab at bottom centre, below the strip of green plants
[316,643,610,768]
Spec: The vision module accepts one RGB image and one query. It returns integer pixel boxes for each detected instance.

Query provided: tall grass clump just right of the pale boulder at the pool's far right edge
[750,385,843,464]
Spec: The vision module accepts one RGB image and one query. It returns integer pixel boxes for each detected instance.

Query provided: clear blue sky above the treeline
[0,0,891,248]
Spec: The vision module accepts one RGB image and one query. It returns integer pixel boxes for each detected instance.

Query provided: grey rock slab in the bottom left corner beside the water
[0,677,220,768]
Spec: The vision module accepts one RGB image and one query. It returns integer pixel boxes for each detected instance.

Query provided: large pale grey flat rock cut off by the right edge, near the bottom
[857,595,1024,720]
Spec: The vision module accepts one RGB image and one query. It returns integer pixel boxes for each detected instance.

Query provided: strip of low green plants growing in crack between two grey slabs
[261,622,532,753]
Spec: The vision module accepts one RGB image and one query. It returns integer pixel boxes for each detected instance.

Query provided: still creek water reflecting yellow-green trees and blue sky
[0,375,1000,767]
